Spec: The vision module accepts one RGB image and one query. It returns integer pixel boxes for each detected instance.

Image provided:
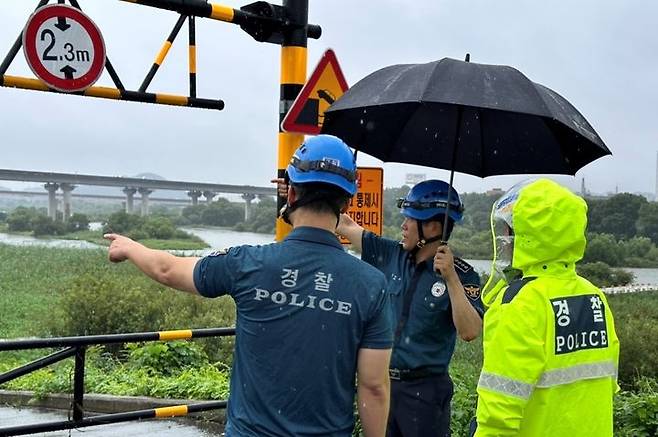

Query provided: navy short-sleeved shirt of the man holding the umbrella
[361,232,484,373]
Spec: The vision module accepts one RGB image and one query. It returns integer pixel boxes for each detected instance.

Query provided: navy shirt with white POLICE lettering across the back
[194,227,393,437]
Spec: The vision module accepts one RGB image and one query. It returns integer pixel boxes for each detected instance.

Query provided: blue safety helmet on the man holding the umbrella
[398,179,464,222]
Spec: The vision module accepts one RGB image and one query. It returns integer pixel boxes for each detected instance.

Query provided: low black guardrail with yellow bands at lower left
[0,328,235,436]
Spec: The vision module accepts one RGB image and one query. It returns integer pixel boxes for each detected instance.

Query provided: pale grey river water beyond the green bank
[0,228,658,285]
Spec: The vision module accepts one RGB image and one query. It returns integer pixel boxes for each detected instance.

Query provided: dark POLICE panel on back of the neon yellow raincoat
[551,294,608,355]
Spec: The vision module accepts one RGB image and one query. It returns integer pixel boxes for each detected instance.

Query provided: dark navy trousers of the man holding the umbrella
[386,373,453,437]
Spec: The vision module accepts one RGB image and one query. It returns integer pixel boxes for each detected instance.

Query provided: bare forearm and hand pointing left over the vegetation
[103,234,199,294]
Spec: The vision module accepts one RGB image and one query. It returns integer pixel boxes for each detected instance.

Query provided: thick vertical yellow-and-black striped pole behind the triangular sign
[276,0,308,241]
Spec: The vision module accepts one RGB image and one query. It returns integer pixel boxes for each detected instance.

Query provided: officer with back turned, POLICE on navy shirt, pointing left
[106,135,393,437]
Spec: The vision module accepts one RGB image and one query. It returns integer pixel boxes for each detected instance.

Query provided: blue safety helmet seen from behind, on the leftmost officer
[287,135,356,196]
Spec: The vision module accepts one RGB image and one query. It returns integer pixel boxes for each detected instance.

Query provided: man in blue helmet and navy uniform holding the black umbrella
[338,180,483,437]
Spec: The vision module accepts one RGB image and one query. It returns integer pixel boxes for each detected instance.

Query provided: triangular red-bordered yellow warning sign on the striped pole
[281,49,349,135]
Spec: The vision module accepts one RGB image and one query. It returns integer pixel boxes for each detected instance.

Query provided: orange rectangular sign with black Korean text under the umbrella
[341,167,384,244]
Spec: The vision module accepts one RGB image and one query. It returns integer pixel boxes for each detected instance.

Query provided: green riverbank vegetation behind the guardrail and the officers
[0,244,658,436]
